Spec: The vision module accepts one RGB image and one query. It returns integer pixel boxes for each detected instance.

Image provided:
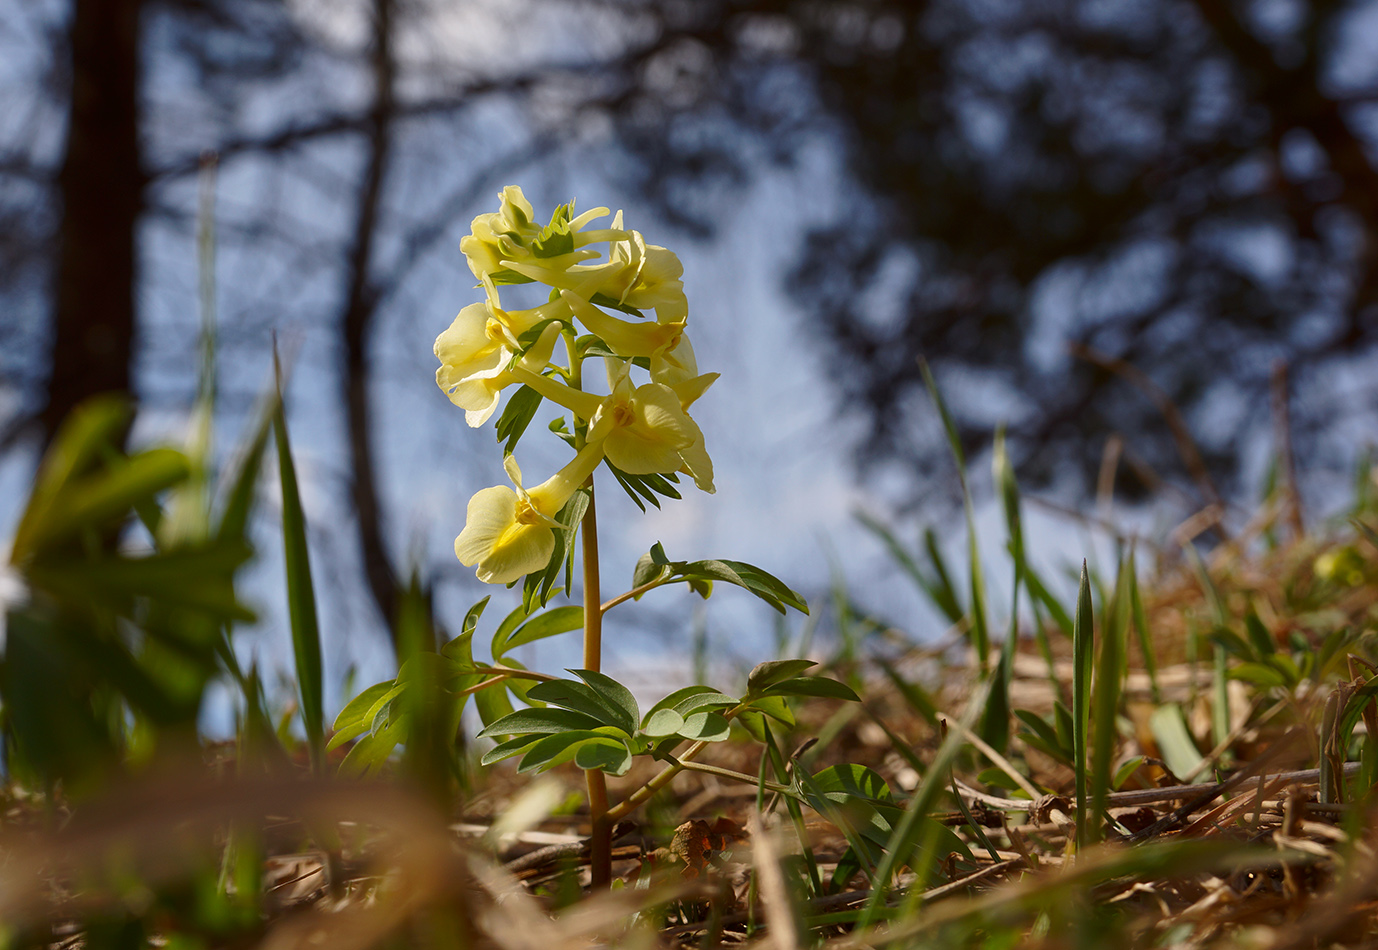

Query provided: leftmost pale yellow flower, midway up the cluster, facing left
[435,292,569,427]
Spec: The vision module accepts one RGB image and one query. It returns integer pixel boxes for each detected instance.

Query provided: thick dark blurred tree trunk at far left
[40,0,143,443]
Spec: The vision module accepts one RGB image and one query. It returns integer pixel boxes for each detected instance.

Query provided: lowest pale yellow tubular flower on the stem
[455,443,602,583]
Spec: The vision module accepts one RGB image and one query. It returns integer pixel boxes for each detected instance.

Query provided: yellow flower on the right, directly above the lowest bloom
[513,360,717,492]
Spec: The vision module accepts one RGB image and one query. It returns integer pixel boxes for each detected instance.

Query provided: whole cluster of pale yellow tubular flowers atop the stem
[435,186,718,583]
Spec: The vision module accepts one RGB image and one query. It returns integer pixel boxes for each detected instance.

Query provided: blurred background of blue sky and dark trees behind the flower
[0,0,1378,709]
